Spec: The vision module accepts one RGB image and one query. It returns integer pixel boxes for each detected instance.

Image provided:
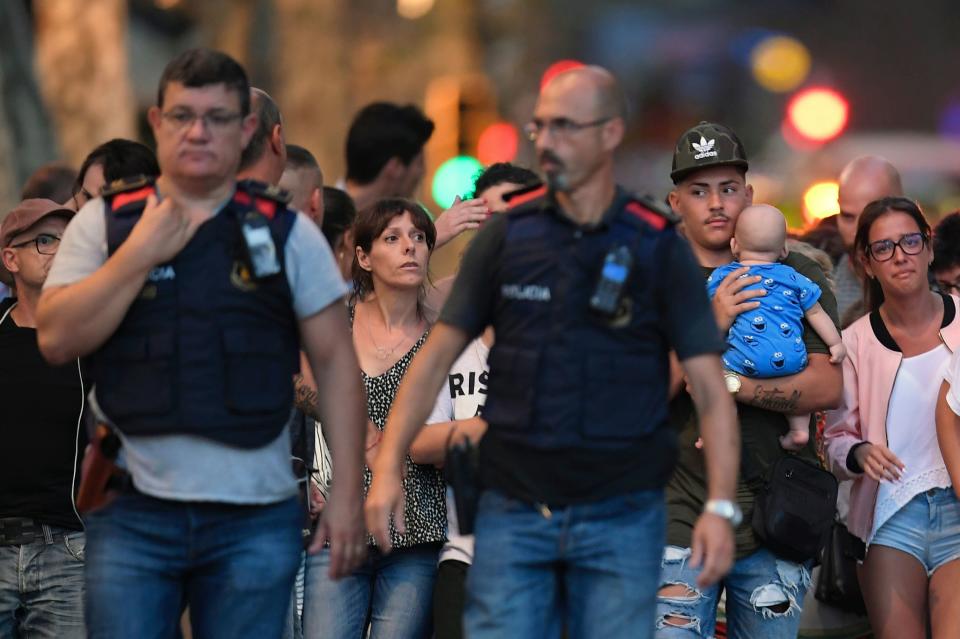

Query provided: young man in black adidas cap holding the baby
[657,122,842,639]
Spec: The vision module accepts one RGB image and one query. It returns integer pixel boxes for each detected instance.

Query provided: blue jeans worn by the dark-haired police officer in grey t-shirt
[85,493,303,639]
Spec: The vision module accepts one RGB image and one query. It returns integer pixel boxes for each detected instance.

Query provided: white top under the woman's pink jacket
[867,344,951,543]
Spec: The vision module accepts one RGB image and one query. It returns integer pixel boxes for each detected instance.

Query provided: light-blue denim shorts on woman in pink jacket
[867,487,960,576]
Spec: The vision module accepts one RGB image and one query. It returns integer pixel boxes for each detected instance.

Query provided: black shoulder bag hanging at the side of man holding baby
[753,455,837,563]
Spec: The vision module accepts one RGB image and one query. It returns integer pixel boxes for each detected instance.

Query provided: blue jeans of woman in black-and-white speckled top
[303,545,440,639]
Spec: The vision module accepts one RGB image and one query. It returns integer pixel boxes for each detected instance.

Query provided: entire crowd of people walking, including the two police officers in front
[0,49,960,639]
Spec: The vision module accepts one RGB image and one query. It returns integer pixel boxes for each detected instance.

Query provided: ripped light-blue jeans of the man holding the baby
[656,546,810,639]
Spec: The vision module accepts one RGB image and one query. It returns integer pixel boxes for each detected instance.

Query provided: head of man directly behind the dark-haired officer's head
[237,87,287,185]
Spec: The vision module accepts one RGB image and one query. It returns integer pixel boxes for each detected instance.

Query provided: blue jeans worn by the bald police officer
[464,490,664,639]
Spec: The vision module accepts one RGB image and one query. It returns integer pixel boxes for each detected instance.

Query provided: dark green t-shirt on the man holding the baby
[666,253,840,559]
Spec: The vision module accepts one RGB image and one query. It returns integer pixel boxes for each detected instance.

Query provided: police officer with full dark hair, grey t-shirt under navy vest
[38,49,366,637]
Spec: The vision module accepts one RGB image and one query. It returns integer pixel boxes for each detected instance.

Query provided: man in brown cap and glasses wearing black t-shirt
[0,199,87,638]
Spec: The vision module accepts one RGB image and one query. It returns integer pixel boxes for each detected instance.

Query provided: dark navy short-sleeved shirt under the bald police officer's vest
[439,189,725,506]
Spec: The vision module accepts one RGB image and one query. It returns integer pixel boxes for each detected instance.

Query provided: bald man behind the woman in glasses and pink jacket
[833,155,903,326]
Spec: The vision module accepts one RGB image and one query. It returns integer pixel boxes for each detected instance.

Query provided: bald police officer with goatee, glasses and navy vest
[366,67,739,639]
